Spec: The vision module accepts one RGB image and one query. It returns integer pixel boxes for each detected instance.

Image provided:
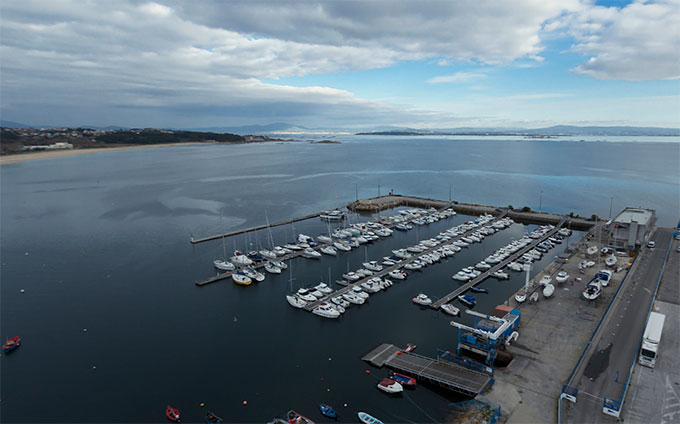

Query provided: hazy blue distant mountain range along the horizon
[0,120,680,137]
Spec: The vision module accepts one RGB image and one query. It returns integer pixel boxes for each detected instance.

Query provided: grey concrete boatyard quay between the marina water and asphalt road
[484,228,632,423]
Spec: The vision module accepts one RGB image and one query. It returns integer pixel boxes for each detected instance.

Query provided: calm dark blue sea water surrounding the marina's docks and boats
[0,136,680,422]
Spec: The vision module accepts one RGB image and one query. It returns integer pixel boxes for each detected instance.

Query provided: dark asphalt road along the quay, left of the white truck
[568,228,672,423]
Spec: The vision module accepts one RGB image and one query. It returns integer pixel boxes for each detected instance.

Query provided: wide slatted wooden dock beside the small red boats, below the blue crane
[361,343,493,396]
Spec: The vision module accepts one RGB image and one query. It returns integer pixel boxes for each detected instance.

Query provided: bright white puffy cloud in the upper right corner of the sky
[548,0,680,81]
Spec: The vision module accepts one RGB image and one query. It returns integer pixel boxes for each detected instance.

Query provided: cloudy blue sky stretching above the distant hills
[0,0,680,129]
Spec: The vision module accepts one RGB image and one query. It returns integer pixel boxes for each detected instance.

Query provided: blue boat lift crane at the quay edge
[450,309,520,367]
